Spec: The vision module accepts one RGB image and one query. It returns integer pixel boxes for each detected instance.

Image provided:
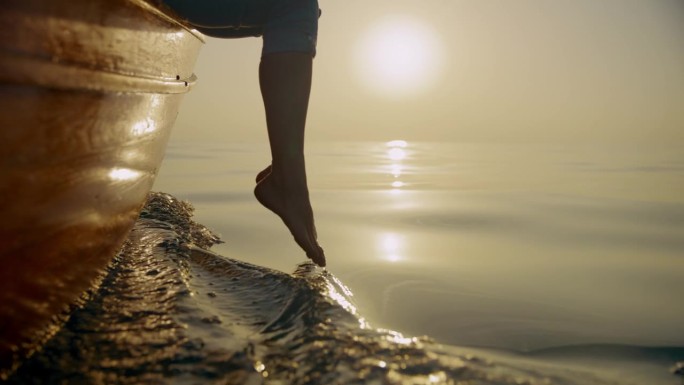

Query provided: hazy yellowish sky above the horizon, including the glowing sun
[168,0,684,143]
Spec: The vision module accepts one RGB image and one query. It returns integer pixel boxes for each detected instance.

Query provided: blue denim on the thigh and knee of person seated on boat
[163,0,320,56]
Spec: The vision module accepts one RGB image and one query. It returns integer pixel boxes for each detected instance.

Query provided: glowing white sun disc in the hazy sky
[354,15,444,97]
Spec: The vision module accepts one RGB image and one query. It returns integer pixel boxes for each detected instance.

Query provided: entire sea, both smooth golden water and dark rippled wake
[14,139,684,385]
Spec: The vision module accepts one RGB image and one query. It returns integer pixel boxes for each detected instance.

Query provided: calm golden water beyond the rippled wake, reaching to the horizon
[155,139,684,383]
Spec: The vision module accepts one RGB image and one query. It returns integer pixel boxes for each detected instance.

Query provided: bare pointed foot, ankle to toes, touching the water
[254,166,325,267]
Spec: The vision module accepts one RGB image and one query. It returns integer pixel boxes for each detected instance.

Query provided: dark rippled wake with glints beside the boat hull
[9,194,682,384]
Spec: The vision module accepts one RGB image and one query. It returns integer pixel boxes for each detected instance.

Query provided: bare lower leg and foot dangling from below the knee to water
[254,52,325,266]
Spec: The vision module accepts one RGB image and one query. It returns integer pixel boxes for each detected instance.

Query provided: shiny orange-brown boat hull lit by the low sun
[0,0,202,379]
